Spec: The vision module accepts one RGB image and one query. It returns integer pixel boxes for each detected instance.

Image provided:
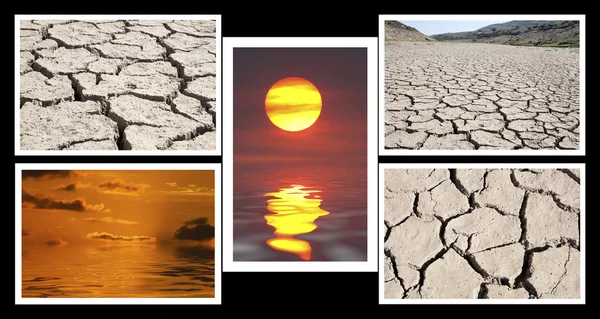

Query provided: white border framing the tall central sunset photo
[222,37,377,272]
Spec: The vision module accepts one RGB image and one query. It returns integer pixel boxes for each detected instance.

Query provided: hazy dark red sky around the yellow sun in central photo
[233,48,366,168]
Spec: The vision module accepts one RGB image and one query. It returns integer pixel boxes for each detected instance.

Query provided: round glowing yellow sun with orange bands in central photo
[265,77,323,132]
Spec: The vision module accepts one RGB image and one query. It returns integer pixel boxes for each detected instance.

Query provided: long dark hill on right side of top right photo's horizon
[431,20,579,47]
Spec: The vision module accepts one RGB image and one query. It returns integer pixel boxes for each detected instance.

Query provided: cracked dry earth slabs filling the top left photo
[20,20,216,150]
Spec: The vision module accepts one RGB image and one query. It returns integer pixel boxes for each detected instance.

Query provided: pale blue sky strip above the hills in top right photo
[400,20,510,35]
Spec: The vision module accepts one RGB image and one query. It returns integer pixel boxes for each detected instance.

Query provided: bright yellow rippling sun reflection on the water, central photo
[264,185,329,260]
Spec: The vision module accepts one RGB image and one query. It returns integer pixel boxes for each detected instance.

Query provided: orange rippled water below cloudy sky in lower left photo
[22,245,215,298]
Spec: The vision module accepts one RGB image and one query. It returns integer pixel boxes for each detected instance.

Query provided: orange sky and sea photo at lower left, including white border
[15,163,222,305]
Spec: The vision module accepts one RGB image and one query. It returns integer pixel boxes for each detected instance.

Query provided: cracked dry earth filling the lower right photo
[384,169,580,299]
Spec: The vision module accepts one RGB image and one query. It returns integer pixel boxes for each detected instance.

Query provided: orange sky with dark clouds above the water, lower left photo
[22,170,215,248]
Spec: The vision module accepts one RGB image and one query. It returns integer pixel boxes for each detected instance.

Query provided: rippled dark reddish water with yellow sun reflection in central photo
[233,164,367,261]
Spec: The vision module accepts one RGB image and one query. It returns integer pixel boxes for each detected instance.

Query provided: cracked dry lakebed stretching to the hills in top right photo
[385,42,580,150]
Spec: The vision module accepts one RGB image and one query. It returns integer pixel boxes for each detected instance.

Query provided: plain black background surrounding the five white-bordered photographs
[10,6,597,312]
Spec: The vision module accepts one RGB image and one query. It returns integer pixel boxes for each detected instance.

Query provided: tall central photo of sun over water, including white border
[223,38,377,272]
